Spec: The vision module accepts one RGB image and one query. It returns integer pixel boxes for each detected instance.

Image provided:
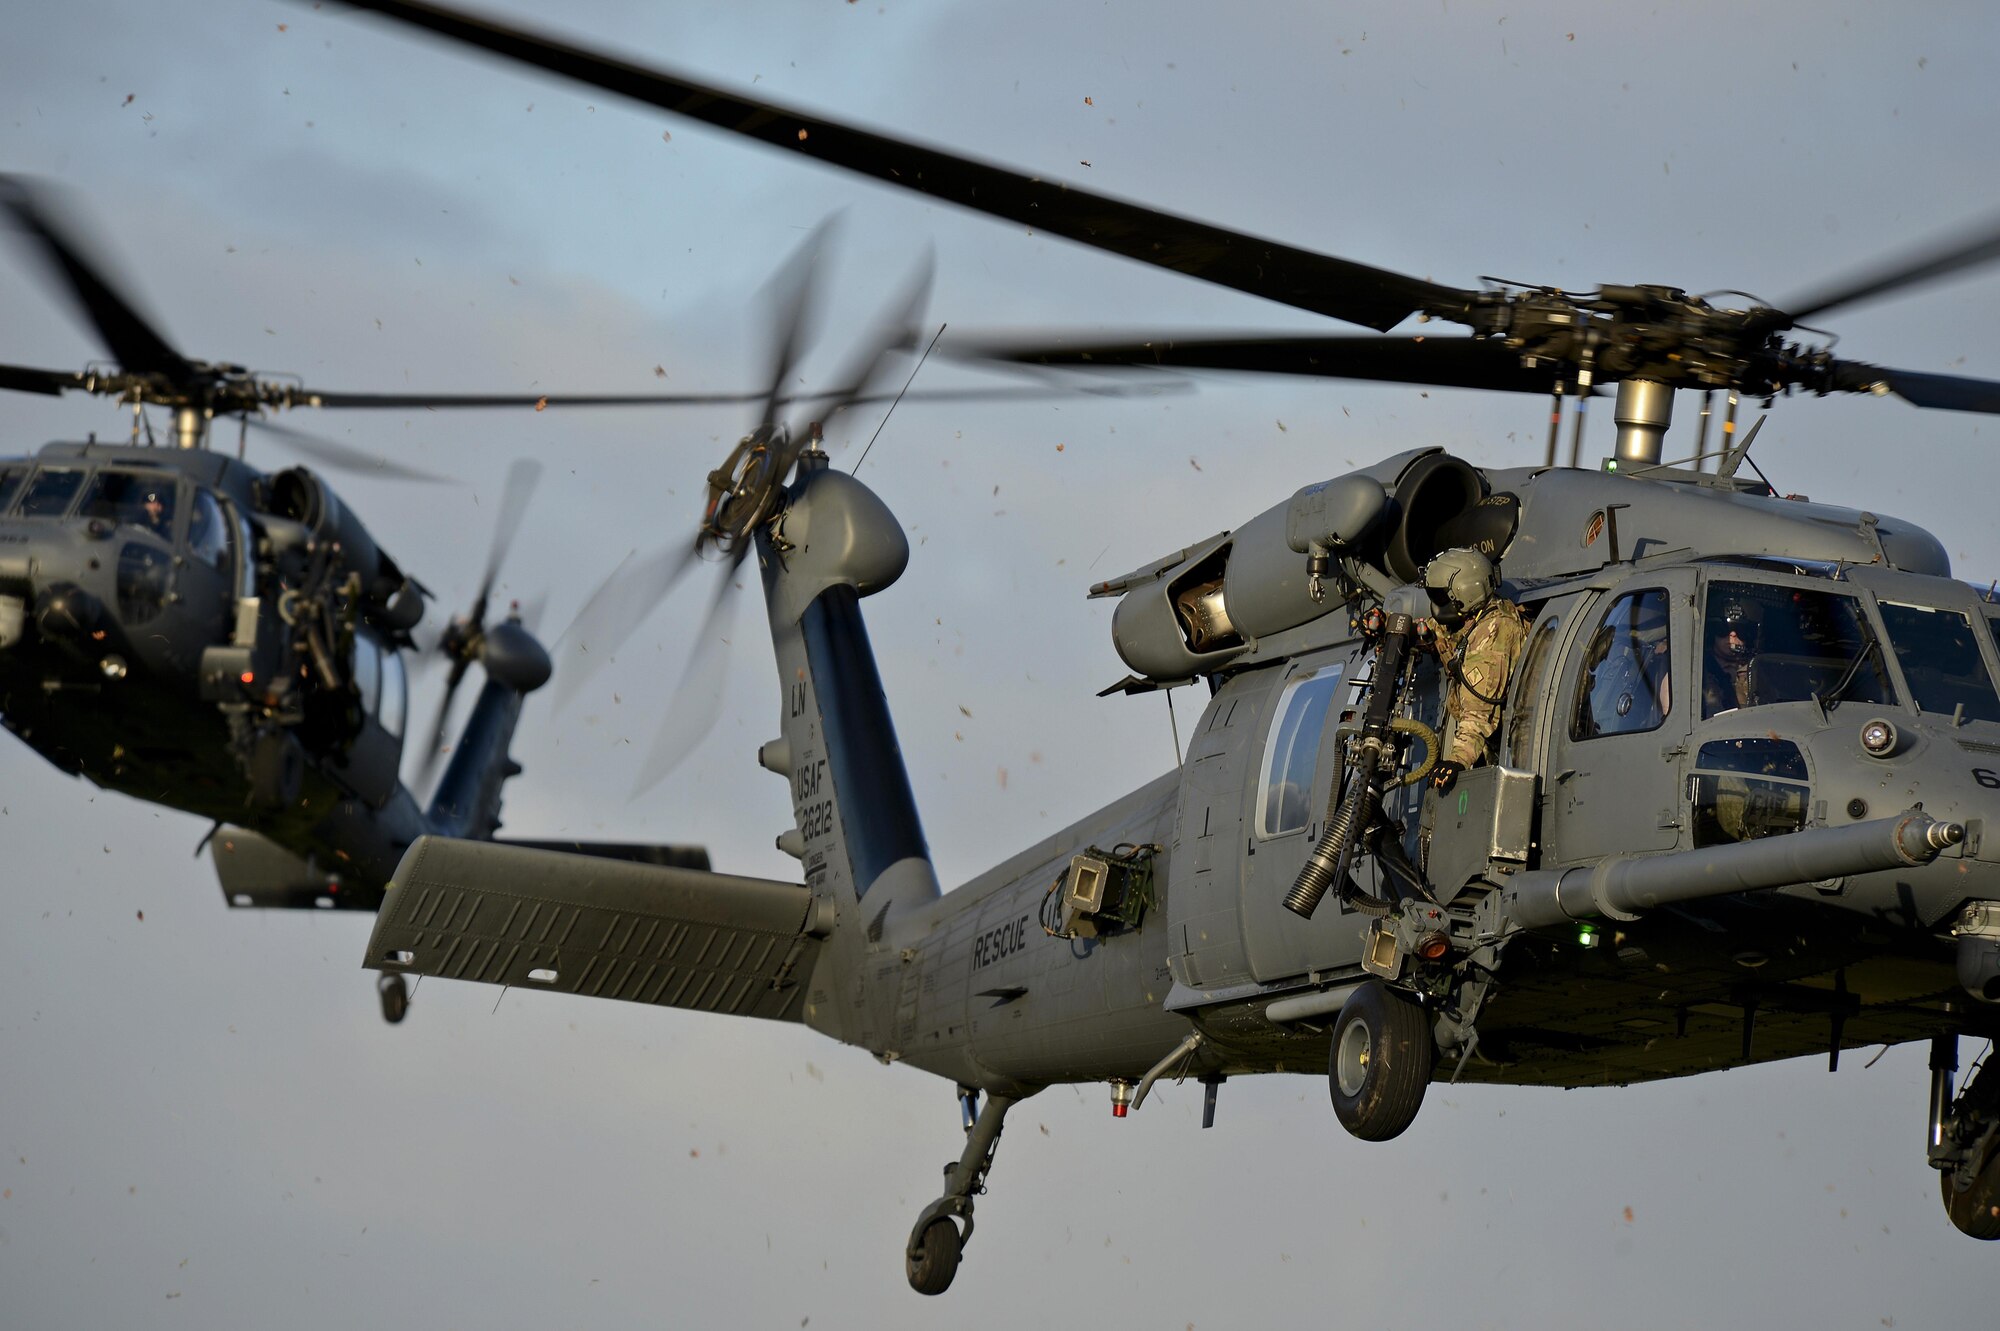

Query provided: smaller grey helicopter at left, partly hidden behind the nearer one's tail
[0,176,852,1021]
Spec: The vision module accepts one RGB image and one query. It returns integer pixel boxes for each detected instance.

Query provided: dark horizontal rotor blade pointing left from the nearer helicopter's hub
[944,334,1566,394]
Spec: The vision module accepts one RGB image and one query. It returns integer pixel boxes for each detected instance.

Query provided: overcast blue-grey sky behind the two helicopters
[0,0,2000,1329]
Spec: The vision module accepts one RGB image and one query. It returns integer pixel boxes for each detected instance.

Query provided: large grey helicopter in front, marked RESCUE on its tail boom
[324,2,2000,1293]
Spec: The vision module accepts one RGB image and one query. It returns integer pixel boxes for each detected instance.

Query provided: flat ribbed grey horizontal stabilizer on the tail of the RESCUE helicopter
[366,837,820,1021]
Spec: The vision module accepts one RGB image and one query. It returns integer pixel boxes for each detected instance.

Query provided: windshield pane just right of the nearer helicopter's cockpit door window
[1702,582,1894,717]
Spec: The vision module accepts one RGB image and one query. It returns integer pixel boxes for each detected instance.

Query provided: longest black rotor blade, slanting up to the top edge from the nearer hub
[332,0,1476,332]
